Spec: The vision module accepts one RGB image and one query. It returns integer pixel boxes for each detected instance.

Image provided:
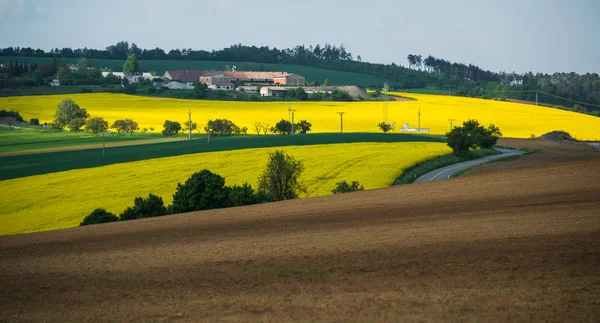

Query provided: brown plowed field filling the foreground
[0,141,600,322]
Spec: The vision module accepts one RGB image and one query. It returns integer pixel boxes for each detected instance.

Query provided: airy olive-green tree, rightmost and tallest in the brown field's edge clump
[258,150,304,201]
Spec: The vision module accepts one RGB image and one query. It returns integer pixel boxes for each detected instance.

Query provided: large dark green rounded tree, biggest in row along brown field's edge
[169,169,229,214]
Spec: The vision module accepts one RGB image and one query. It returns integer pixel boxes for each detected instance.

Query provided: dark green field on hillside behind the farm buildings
[0,56,404,87]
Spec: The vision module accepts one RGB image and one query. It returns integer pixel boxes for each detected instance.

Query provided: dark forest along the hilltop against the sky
[0,41,600,114]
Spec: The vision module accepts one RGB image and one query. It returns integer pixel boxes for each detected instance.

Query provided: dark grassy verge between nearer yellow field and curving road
[394,149,498,185]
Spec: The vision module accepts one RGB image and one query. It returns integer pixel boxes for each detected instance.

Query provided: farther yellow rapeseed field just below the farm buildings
[0,93,600,140]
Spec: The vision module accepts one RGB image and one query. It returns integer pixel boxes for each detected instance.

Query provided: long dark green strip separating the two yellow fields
[0,133,443,180]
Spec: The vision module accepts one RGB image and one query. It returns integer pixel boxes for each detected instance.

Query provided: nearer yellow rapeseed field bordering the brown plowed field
[0,142,451,235]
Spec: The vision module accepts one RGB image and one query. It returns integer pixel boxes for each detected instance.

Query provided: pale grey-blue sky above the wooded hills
[0,0,600,73]
